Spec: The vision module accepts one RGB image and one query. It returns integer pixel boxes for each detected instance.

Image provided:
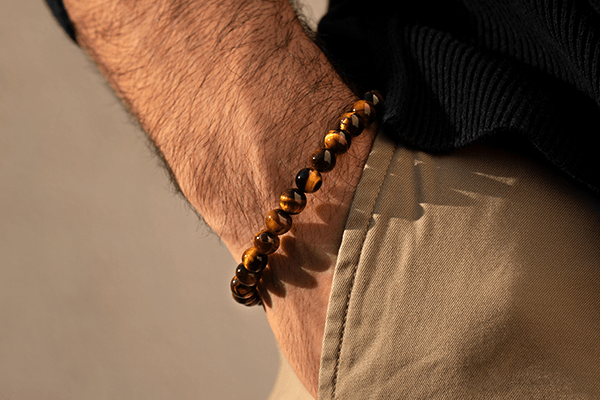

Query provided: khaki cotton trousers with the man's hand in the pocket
[272,135,600,400]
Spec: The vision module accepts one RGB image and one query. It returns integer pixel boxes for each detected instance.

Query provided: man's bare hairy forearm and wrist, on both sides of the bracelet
[64,0,374,398]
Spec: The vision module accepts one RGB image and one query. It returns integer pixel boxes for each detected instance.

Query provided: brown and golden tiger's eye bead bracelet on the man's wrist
[231,91,383,306]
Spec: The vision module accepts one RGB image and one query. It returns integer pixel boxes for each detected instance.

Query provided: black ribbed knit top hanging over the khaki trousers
[317,0,600,193]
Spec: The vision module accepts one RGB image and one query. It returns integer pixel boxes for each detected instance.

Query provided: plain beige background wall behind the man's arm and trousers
[0,0,324,400]
